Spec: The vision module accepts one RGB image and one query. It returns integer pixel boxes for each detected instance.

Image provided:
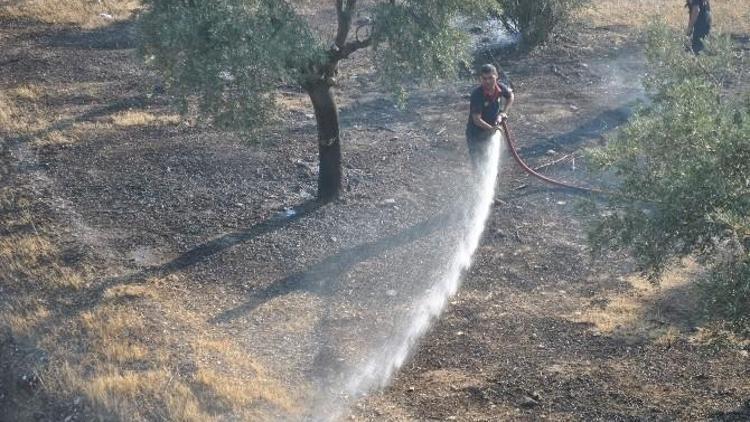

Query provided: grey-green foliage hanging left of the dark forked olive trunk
[140,0,325,128]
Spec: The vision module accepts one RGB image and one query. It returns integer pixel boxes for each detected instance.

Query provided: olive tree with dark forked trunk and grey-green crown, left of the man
[140,0,497,201]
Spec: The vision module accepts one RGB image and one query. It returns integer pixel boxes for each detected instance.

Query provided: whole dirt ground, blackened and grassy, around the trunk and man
[0,5,750,422]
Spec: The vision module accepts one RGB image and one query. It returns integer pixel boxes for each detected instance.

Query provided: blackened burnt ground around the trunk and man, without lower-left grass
[0,11,750,421]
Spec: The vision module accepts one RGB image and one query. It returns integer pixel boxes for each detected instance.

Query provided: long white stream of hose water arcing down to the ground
[312,134,501,421]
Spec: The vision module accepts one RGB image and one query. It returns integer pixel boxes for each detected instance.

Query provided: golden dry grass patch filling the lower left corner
[0,179,295,421]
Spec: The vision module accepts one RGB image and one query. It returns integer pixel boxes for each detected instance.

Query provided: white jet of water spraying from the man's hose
[317,134,501,420]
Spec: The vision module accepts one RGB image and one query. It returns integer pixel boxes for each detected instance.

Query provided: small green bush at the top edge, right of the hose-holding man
[497,0,587,47]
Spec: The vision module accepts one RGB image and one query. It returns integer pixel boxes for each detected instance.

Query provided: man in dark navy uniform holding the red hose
[466,64,514,169]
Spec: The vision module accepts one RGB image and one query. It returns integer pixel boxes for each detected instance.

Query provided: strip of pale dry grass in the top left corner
[0,0,141,28]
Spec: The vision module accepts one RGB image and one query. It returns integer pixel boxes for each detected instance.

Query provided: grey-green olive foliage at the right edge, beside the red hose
[590,26,750,319]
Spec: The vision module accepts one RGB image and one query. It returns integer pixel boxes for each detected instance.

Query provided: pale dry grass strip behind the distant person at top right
[580,0,750,34]
